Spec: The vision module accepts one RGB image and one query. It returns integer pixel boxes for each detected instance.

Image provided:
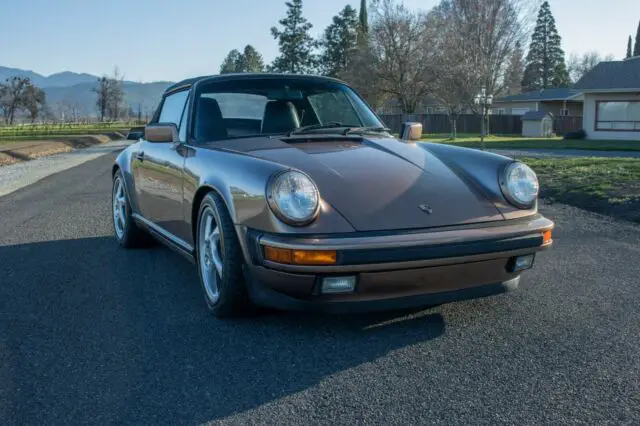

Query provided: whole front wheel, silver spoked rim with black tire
[196,193,251,318]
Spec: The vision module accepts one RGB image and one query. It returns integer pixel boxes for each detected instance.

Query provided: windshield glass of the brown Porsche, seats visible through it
[193,78,384,141]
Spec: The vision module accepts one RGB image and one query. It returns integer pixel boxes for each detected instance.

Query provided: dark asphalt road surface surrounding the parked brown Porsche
[0,154,640,425]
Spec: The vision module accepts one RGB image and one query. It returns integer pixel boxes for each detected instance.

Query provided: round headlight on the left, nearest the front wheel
[267,171,320,226]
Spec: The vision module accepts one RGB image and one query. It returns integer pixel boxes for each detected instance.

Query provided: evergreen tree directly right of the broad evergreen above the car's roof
[320,5,359,77]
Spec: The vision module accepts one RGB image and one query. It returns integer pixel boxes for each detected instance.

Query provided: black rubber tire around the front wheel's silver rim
[195,192,253,318]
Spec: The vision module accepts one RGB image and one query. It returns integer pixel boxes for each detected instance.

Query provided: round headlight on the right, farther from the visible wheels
[500,162,540,209]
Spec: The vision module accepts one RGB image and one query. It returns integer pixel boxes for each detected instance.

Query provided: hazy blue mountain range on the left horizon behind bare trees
[0,66,173,117]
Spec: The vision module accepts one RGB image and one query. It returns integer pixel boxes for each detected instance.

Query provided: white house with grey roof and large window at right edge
[573,56,640,142]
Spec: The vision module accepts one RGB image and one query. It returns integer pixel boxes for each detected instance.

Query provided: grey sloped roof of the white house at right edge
[573,56,640,92]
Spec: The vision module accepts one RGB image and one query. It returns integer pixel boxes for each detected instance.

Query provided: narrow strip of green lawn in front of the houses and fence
[422,134,640,151]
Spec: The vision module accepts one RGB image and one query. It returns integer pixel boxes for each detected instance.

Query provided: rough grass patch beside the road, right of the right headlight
[519,158,640,223]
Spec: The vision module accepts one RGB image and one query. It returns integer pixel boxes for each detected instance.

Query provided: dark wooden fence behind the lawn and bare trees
[380,114,582,135]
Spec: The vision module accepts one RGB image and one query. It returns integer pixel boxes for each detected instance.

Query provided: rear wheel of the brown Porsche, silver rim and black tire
[111,171,152,248]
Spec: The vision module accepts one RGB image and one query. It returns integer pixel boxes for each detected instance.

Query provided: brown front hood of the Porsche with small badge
[212,138,504,231]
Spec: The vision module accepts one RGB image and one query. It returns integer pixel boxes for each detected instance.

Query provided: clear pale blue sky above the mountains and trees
[0,0,640,81]
